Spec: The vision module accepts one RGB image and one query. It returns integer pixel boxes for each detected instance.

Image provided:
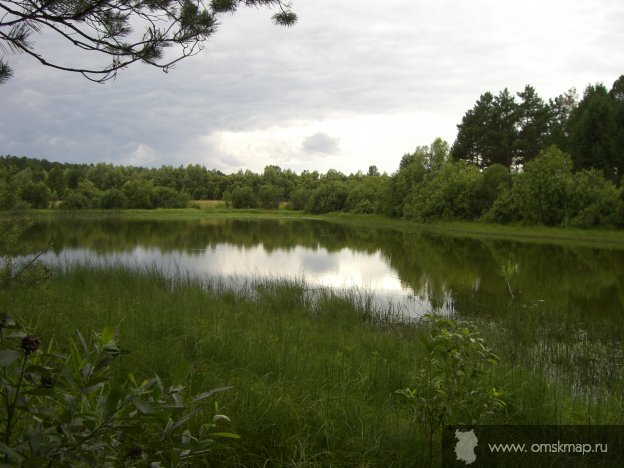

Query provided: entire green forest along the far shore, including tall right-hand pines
[0,75,624,227]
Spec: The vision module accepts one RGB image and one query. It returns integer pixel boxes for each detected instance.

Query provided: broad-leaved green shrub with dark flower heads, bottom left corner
[0,314,237,466]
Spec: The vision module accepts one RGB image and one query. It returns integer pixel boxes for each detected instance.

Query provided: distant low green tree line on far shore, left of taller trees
[0,156,389,213]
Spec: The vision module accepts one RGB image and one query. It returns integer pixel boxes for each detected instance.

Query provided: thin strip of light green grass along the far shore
[0,205,624,249]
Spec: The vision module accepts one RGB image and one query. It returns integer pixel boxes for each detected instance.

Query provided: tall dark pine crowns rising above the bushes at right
[451,75,624,184]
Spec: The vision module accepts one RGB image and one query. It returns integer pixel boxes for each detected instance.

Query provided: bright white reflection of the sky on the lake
[29,230,448,318]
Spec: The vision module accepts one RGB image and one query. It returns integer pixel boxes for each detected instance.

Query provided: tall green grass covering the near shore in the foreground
[0,265,622,467]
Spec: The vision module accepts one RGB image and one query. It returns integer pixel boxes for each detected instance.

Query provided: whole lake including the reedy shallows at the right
[4,216,624,390]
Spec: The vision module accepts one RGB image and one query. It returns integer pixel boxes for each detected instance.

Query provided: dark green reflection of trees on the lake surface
[8,217,624,320]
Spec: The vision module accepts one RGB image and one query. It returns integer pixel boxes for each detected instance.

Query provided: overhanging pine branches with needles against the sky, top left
[0,0,297,84]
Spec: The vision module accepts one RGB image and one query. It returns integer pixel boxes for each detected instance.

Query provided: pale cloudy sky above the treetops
[0,0,624,174]
